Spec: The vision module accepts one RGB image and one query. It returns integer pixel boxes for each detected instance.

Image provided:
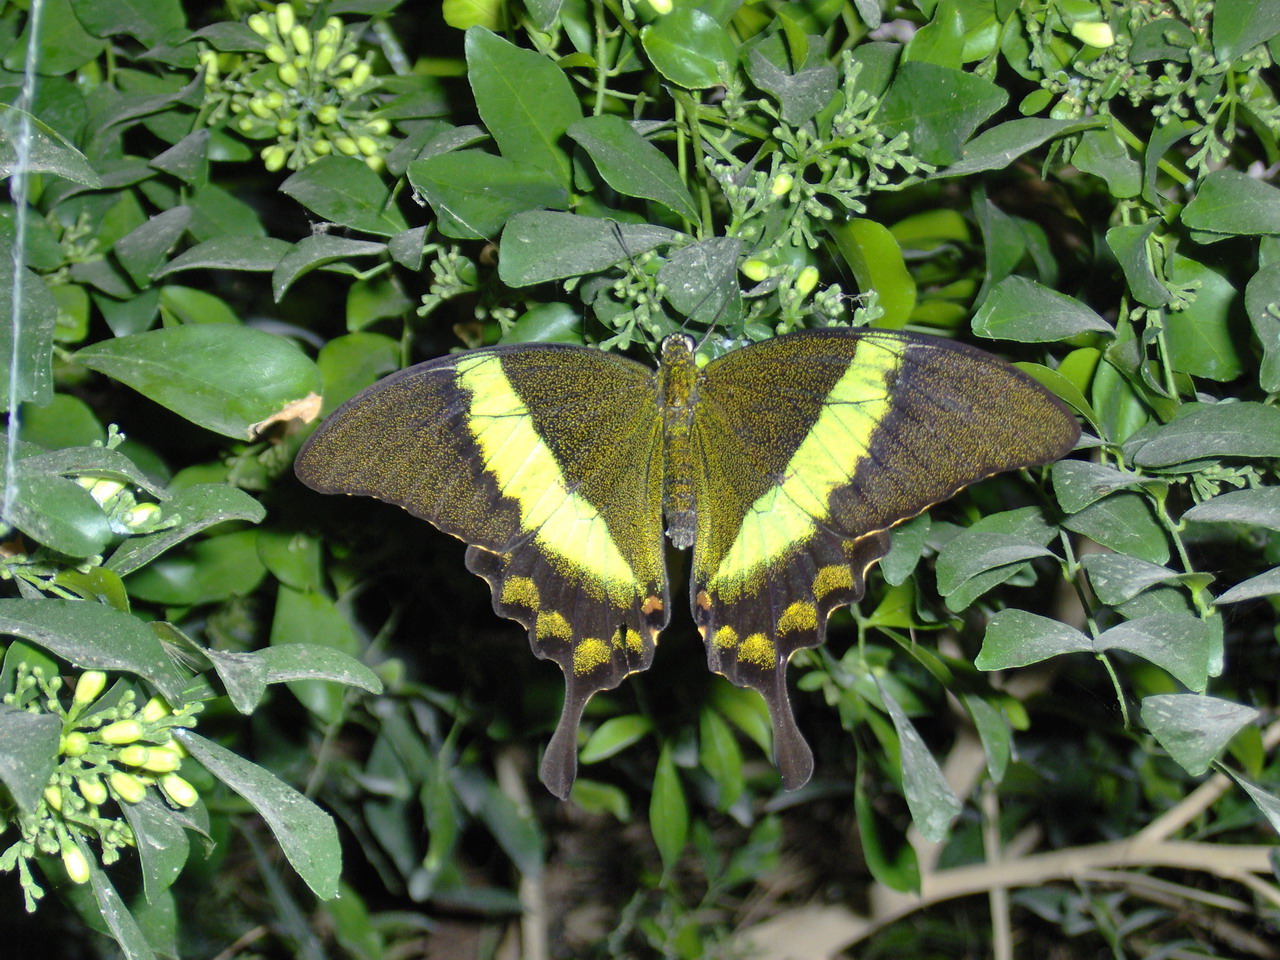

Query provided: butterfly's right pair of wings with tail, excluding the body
[690,330,1079,790]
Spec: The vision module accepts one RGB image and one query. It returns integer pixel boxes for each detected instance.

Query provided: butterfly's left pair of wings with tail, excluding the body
[294,344,669,799]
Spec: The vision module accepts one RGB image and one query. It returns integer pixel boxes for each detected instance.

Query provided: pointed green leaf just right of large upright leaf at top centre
[565,114,698,221]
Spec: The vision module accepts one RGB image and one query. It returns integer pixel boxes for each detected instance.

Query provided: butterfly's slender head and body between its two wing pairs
[658,333,698,549]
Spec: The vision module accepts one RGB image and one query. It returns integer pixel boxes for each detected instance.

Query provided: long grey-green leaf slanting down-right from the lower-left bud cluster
[177,730,342,900]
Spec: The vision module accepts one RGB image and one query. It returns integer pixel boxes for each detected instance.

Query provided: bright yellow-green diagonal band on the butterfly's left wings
[457,353,637,598]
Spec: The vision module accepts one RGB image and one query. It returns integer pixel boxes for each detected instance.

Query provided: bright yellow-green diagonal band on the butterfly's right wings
[710,339,905,593]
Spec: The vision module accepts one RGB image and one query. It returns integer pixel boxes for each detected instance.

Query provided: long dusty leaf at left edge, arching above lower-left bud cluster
[0,599,186,704]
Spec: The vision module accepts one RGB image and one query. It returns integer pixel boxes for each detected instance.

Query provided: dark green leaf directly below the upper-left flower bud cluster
[280,155,408,237]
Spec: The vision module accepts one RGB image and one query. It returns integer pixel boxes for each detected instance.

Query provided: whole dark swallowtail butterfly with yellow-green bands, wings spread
[294,328,1080,799]
